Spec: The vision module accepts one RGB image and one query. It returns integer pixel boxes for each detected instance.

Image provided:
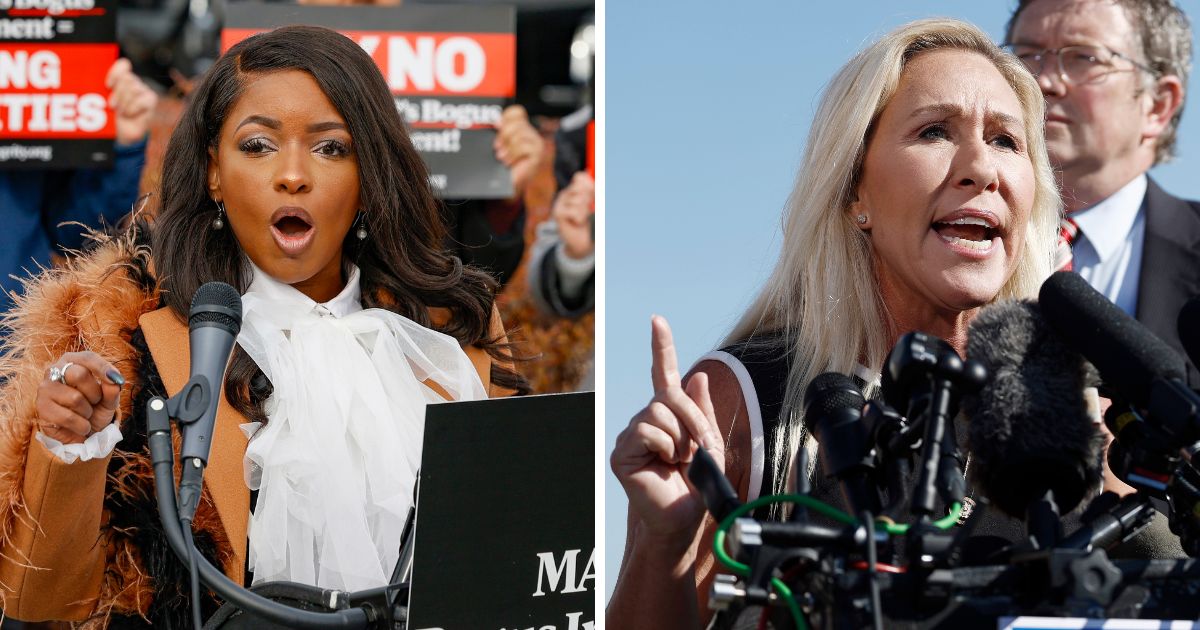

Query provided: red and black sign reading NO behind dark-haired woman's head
[225,0,516,199]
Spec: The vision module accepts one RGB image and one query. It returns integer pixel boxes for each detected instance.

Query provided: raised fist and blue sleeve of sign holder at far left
[0,59,158,319]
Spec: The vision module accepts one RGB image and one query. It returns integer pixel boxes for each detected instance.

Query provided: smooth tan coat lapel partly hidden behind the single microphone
[138,308,250,584]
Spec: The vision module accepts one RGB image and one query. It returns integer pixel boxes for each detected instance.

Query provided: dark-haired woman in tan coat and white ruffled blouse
[0,26,527,628]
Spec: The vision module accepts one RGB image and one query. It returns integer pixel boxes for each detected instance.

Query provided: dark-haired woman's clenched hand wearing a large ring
[37,352,125,444]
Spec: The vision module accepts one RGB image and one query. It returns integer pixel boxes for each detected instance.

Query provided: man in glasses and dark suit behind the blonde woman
[1006,0,1200,386]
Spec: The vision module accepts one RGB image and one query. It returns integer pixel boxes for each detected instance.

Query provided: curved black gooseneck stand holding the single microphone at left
[146,390,388,629]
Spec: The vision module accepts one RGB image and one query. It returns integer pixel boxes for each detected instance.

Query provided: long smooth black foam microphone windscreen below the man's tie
[1038,271,1184,408]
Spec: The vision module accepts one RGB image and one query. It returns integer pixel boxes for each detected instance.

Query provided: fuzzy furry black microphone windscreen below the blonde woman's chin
[962,301,1104,520]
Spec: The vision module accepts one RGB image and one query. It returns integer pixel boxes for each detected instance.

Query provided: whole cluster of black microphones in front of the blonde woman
[689,272,1200,625]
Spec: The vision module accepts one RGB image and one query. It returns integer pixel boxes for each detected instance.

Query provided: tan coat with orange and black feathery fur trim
[0,231,508,628]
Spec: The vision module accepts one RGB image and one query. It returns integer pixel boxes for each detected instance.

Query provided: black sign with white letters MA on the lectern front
[408,391,596,630]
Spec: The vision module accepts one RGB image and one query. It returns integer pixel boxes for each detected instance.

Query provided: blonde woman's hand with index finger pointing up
[611,316,725,545]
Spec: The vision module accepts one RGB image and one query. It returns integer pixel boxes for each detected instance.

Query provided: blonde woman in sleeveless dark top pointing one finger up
[607,19,1061,630]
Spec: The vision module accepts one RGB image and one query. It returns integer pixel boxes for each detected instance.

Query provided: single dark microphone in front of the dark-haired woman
[178,282,241,520]
